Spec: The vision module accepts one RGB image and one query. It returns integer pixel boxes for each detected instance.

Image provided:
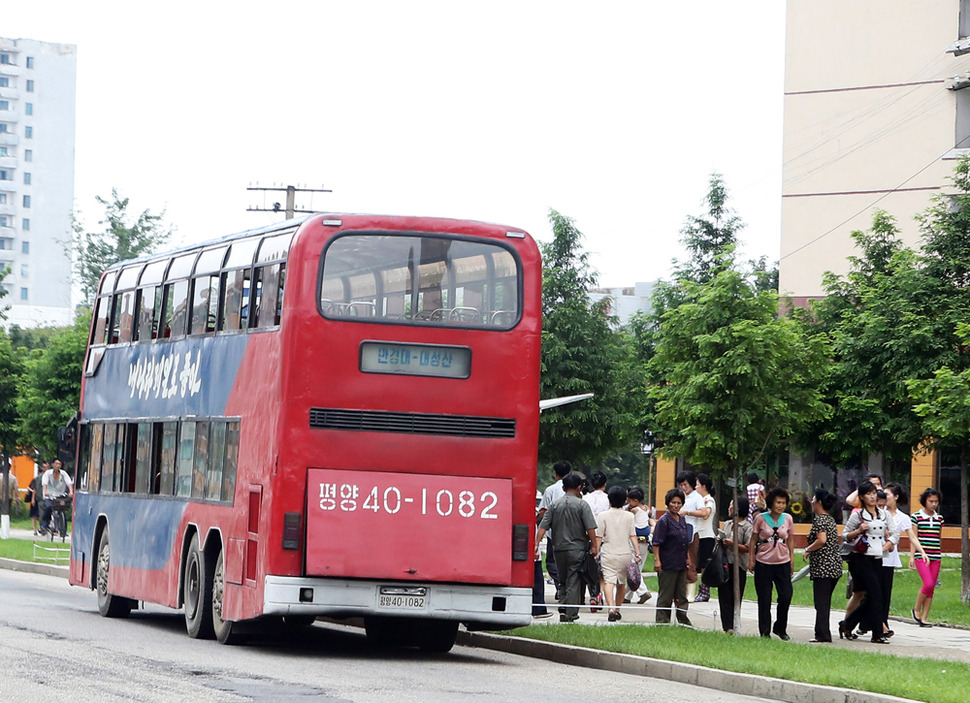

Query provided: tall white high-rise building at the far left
[0,38,77,327]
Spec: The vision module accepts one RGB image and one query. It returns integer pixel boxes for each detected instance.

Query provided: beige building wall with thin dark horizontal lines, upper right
[779,0,970,303]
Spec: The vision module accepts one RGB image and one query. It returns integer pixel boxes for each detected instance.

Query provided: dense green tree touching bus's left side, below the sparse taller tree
[16,313,91,457]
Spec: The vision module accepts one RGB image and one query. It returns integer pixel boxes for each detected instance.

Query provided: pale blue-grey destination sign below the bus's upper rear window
[360,342,472,378]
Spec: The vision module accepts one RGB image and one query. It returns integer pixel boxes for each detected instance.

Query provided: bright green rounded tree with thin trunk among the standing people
[649,260,828,631]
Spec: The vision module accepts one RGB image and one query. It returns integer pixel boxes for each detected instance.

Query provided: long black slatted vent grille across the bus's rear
[310,408,515,437]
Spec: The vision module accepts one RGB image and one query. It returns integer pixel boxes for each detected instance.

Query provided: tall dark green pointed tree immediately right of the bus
[539,210,636,470]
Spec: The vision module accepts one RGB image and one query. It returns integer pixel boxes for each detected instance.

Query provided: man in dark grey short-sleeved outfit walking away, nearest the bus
[536,473,596,622]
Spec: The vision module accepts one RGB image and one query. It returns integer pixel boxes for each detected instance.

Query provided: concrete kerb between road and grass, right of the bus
[458,631,913,703]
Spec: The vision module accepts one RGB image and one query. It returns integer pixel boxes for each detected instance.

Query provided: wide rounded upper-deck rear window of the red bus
[320,234,520,329]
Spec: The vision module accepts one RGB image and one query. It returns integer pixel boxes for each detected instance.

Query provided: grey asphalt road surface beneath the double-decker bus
[0,571,757,703]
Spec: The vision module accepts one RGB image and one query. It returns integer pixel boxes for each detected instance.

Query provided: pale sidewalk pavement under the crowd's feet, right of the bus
[533,573,970,663]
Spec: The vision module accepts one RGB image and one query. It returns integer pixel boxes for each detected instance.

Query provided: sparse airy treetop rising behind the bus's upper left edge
[73,188,171,306]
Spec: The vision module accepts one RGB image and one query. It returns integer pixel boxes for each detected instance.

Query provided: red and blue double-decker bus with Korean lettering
[70,214,541,651]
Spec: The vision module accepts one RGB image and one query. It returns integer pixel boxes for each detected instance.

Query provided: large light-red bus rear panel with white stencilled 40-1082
[306,469,512,584]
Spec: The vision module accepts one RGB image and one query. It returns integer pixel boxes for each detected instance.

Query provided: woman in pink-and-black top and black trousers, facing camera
[748,488,795,640]
